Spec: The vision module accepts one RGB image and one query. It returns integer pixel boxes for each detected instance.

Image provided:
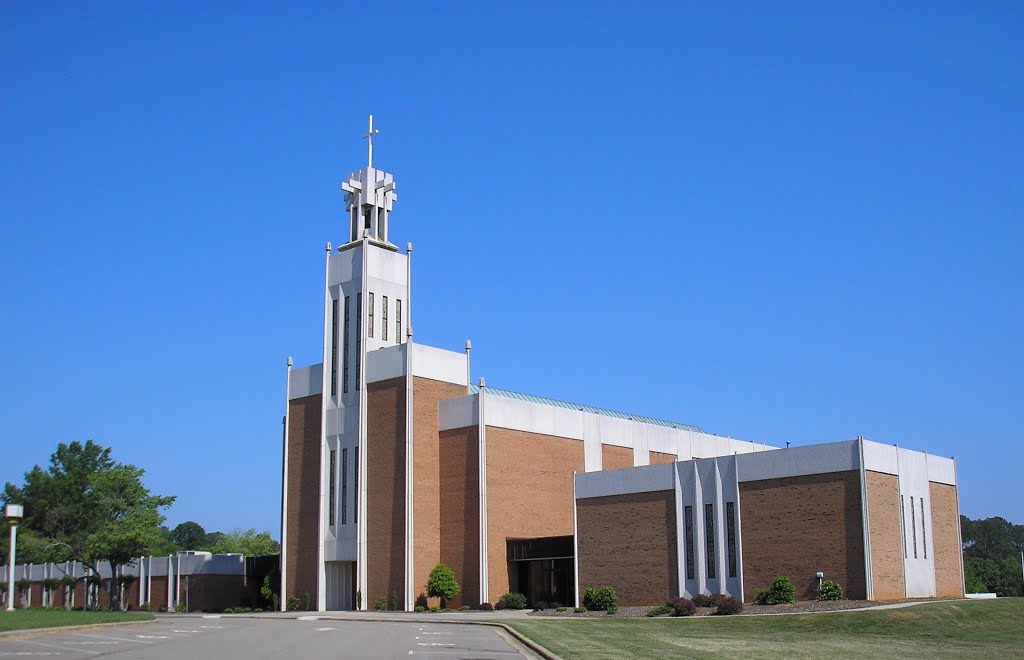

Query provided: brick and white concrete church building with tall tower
[281,118,964,611]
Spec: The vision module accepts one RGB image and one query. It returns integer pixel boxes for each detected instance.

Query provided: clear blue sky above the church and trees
[0,2,1024,536]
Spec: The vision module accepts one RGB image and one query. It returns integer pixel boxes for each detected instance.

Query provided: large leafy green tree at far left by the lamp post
[3,440,174,609]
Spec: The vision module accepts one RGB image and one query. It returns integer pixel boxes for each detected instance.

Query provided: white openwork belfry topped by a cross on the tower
[341,115,398,250]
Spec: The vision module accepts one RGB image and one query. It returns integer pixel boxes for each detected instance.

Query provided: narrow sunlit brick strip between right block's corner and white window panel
[864,471,906,601]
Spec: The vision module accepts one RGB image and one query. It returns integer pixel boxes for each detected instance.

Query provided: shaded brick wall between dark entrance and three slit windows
[577,490,679,606]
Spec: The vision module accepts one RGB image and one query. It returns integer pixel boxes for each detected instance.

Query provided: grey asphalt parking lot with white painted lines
[0,616,532,660]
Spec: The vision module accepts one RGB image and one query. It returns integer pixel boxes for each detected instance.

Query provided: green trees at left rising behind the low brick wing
[0,440,280,609]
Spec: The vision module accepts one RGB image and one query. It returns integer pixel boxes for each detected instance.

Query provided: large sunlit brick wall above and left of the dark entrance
[486,427,581,603]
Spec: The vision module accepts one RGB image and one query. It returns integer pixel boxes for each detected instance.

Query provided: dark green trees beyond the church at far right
[961,516,1024,596]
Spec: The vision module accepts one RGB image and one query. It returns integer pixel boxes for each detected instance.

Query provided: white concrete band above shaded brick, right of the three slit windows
[737,440,860,481]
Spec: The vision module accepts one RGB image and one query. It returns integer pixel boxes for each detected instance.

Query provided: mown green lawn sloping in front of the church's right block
[507,599,1024,660]
